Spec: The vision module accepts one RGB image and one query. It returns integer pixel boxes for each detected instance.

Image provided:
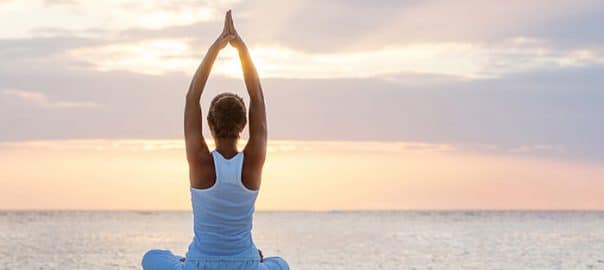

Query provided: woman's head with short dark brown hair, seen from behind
[208,93,247,139]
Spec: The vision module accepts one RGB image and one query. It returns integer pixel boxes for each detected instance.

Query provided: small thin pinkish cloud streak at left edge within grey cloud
[1,89,98,109]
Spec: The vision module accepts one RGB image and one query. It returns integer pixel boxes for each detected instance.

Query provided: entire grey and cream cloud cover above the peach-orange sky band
[0,1,604,162]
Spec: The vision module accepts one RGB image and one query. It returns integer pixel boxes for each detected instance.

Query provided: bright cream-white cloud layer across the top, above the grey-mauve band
[0,1,604,79]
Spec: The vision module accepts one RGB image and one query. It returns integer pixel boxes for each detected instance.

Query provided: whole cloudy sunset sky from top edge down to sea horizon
[0,0,604,210]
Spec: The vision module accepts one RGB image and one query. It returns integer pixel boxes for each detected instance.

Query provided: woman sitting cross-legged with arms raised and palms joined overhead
[142,11,289,270]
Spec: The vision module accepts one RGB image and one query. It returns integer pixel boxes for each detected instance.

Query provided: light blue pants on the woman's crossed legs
[142,249,289,270]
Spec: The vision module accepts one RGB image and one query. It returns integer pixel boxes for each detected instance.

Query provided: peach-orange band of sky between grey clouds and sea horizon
[0,140,604,210]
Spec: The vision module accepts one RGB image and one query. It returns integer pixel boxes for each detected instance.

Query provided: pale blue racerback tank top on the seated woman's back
[187,150,258,257]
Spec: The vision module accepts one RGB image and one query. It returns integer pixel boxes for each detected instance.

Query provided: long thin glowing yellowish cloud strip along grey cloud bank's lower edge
[0,139,566,159]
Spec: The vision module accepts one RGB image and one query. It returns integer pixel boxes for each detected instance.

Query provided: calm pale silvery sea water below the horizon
[0,212,604,270]
